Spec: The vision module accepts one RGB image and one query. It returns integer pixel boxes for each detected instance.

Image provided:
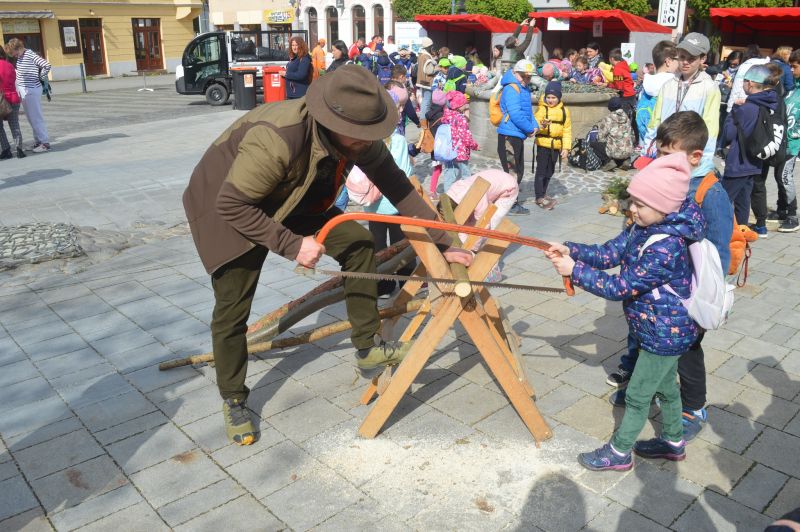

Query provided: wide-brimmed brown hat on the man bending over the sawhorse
[306,65,397,140]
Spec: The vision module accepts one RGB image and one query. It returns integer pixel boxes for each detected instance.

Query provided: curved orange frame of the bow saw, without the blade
[315,212,575,296]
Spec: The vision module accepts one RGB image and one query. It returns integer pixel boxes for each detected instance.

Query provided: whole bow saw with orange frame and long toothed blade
[308,212,575,296]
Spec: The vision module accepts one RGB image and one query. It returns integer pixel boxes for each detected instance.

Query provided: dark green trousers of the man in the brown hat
[211,213,380,400]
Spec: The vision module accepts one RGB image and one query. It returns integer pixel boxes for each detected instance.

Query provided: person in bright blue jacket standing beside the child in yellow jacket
[497,59,539,214]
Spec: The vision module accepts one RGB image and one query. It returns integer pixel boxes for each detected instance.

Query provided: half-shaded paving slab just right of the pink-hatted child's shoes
[664,440,753,494]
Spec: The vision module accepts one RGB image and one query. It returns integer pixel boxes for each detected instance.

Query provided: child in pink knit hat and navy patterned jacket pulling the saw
[545,152,705,471]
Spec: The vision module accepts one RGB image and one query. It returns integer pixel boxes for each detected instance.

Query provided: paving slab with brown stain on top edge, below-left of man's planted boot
[131,449,227,508]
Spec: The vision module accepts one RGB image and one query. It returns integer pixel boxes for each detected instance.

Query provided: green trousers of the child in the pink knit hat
[611,351,683,453]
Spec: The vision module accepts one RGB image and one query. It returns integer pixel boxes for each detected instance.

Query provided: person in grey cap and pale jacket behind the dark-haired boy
[642,32,720,177]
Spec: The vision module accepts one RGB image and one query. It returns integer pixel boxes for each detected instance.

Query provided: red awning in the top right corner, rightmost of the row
[711,7,800,35]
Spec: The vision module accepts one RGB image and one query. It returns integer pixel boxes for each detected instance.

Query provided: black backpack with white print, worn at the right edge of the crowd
[733,98,786,166]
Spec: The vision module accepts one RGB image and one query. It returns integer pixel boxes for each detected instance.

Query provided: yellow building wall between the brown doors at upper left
[0,0,202,80]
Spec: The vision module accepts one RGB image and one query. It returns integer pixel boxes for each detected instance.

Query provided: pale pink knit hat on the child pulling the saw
[628,152,690,214]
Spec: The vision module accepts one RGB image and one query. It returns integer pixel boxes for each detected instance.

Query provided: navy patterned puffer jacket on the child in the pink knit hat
[565,198,706,356]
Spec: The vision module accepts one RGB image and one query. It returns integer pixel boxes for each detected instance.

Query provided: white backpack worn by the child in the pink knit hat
[639,234,736,331]
